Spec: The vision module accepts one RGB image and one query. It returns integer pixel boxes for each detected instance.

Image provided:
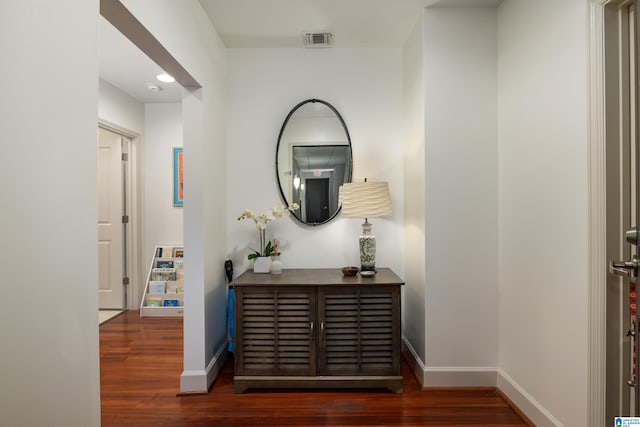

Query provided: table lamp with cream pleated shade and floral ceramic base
[339,178,391,272]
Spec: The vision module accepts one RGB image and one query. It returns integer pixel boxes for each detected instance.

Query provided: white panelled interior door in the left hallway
[98,128,125,309]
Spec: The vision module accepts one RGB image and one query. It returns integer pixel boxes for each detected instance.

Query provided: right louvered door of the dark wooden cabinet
[318,286,401,376]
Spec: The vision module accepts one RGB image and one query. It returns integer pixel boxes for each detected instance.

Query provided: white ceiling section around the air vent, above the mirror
[200,0,502,48]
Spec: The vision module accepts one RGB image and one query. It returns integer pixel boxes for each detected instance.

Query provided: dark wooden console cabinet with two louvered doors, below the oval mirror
[231,268,404,393]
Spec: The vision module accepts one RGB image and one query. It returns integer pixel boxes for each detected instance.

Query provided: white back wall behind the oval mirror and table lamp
[227,48,404,277]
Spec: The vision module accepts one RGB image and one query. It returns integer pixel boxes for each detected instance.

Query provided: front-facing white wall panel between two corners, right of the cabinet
[424,8,498,386]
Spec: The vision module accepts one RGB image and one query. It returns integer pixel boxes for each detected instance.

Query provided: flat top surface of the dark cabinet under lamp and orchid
[230,268,404,287]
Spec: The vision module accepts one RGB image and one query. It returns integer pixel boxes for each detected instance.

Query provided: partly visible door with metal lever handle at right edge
[606,1,640,419]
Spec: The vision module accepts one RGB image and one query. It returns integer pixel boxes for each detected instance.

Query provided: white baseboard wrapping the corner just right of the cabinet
[402,337,497,389]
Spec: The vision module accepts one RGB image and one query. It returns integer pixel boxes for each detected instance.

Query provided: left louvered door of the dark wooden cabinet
[234,287,316,376]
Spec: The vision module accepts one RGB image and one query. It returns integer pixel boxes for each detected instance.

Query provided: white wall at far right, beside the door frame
[498,0,588,426]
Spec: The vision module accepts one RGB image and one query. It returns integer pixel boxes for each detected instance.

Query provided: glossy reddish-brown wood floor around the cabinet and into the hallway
[100,311,526,427]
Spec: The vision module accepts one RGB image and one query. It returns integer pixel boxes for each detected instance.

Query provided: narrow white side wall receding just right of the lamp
[402,16,426,364]
